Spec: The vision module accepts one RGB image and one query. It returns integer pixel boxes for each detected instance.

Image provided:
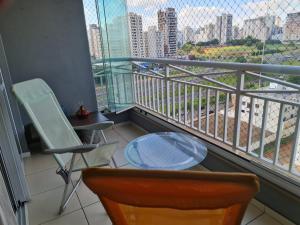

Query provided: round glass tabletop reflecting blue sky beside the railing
[125,132,207,170]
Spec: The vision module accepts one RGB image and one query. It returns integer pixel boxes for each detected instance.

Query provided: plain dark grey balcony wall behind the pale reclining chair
[0,0,96,124]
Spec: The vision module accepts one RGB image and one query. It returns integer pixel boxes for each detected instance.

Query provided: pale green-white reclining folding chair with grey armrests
[13,79,116,213]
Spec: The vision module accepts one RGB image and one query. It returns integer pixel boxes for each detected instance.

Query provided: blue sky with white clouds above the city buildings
[83,0,300,30]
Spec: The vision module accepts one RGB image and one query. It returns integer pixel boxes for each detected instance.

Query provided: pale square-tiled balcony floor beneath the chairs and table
[24,123,292,225]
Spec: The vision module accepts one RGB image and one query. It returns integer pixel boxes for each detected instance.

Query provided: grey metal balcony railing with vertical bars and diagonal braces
[131,58,300,178]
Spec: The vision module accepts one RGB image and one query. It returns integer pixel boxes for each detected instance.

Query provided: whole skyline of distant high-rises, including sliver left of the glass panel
[88,8,300,58]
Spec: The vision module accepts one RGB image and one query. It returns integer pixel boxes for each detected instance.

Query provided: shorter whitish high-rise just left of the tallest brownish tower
[147,26,164,58]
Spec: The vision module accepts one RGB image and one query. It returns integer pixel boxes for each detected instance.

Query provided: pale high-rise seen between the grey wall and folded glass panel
[89,24,102,59]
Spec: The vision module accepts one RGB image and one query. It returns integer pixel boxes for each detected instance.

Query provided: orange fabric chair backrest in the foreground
[83,168,259,225]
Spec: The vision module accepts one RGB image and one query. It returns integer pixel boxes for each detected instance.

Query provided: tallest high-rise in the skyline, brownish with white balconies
[157,8,177,57]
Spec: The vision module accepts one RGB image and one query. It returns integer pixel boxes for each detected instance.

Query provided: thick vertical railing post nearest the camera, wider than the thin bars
[233,71,245,149]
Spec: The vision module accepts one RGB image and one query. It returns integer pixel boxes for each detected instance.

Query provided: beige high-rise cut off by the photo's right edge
[283,12,300,42]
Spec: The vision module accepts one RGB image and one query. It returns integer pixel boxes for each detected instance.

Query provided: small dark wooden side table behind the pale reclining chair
[69,111,109,143]
